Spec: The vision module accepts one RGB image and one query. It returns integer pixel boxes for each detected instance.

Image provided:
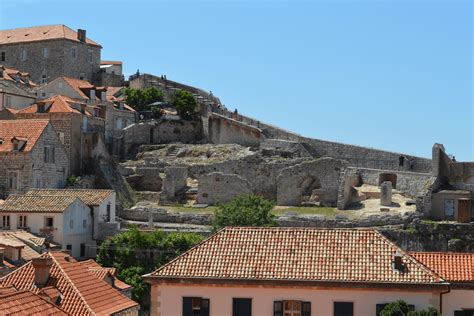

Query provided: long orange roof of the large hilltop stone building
[0,24,100,47]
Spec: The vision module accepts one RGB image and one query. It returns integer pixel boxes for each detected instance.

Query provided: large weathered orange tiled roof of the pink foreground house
[147,227,443,284]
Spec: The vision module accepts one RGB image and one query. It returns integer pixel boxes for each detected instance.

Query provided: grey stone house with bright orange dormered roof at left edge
[0,120,70,197]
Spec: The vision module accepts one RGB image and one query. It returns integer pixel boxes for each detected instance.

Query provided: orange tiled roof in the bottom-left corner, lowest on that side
[0,291,68,316]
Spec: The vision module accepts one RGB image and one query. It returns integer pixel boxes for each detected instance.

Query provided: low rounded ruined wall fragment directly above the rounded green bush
[197,172,252,205]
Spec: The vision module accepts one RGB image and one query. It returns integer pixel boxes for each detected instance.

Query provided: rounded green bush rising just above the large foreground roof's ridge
[212,195,276,230]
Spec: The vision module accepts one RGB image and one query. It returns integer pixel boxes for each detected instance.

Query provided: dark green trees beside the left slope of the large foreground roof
[97,228,203,308]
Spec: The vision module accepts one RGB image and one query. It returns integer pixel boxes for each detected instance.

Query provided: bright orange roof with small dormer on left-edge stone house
[0,120,49,152]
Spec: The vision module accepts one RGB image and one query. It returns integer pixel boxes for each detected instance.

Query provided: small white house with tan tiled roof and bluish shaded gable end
[0,195,96,258]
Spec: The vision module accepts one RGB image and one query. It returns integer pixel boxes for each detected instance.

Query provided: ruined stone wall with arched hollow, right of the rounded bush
[277,158,347,206]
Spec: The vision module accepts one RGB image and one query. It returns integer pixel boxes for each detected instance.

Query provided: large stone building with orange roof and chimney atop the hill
[0,25,102,84]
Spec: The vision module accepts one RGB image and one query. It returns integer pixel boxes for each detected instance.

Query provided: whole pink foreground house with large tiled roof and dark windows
[144,227,462,316]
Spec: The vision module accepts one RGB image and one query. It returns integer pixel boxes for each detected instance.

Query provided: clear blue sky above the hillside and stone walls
[0,0,474,161]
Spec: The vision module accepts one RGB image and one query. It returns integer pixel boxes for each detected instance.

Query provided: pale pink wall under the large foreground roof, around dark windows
[151,285,440,316]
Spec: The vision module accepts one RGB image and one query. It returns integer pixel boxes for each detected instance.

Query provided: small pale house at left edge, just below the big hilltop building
[0,65,36,110]
